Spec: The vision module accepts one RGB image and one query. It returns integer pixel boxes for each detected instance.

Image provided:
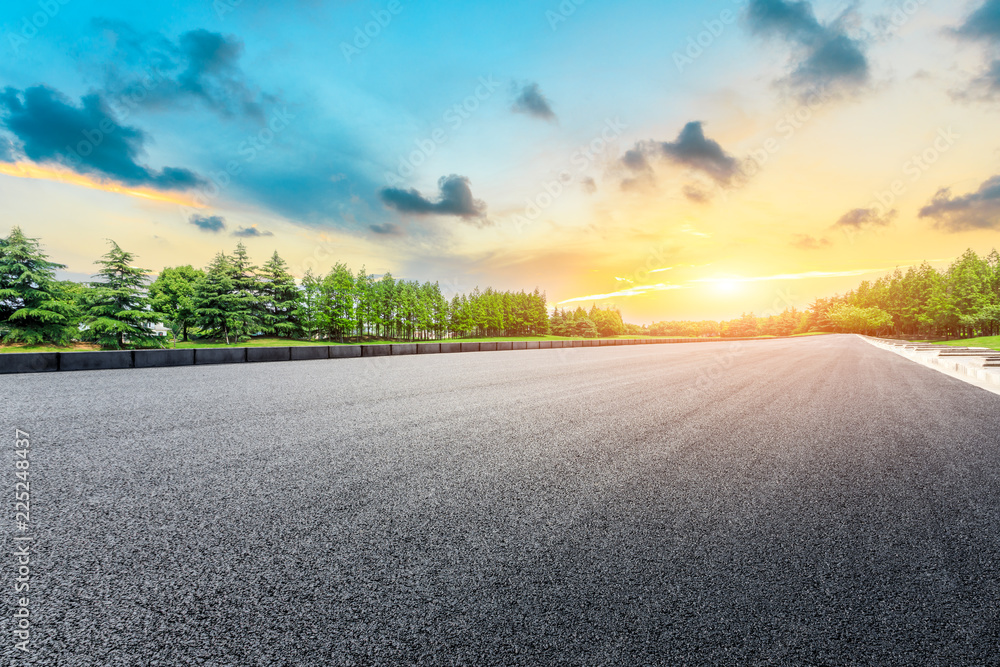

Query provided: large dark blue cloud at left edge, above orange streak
[0,86,204,190]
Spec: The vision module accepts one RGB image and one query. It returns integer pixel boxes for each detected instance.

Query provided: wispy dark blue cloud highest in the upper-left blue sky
[98,21,276,121]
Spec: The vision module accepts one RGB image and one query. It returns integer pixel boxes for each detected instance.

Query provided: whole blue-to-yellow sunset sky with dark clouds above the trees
[0,0,1000,323]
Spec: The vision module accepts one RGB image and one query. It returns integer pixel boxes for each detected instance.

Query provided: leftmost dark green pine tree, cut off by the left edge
[0,227,78,345]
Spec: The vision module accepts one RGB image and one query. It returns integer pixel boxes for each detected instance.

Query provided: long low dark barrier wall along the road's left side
[0,338,800,374]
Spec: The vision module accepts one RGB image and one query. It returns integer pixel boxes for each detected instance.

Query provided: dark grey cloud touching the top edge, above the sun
[746,0,870,96]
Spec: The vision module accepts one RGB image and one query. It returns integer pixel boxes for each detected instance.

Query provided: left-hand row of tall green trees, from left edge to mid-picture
[0,227,549,349]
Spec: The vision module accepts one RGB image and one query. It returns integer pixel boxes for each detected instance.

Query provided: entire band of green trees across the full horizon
[0,227,1000,349]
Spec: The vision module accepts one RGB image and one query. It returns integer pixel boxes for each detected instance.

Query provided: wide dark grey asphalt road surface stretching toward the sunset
[0,336,1000,666]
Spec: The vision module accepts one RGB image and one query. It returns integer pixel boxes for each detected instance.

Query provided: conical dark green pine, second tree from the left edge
[83,241,161,350]
